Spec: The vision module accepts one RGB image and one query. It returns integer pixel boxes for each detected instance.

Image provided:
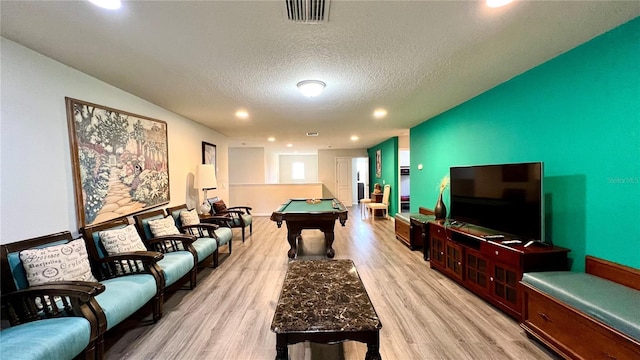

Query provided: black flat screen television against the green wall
[450,162,544,241]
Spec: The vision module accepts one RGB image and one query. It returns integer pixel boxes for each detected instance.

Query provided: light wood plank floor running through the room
[106,207,555,360]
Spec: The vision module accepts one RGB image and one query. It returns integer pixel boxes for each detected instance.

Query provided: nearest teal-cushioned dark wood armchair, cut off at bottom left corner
[0,282,104,360]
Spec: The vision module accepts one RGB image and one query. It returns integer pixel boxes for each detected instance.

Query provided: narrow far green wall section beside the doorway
[367,136,400,216]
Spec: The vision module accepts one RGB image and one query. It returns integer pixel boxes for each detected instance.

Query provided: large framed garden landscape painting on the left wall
[66,98,169,226]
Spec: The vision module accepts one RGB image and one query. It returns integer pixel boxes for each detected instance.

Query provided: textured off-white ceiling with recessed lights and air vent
[0,0,640,153]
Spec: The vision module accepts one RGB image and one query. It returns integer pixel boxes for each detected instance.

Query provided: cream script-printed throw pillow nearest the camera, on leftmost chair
[20,239,98,286]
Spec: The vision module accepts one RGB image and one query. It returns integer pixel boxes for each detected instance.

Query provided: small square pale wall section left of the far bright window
[229,147,265,184]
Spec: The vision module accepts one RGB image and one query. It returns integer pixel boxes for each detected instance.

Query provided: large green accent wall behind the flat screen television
[410,18,640,271]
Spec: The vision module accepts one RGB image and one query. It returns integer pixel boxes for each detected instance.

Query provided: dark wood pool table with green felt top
[271,199,348,259]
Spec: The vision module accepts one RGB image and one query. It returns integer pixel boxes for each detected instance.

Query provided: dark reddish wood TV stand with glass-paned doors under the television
[429,221,570,321]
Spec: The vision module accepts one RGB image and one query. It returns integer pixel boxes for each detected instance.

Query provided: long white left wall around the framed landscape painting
[0,38,229,243]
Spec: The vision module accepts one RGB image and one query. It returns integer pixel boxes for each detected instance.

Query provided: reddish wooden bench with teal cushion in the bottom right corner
[520,256,640,359]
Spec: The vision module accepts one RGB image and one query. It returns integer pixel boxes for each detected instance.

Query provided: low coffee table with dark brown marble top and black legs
[271,260,382,360]
